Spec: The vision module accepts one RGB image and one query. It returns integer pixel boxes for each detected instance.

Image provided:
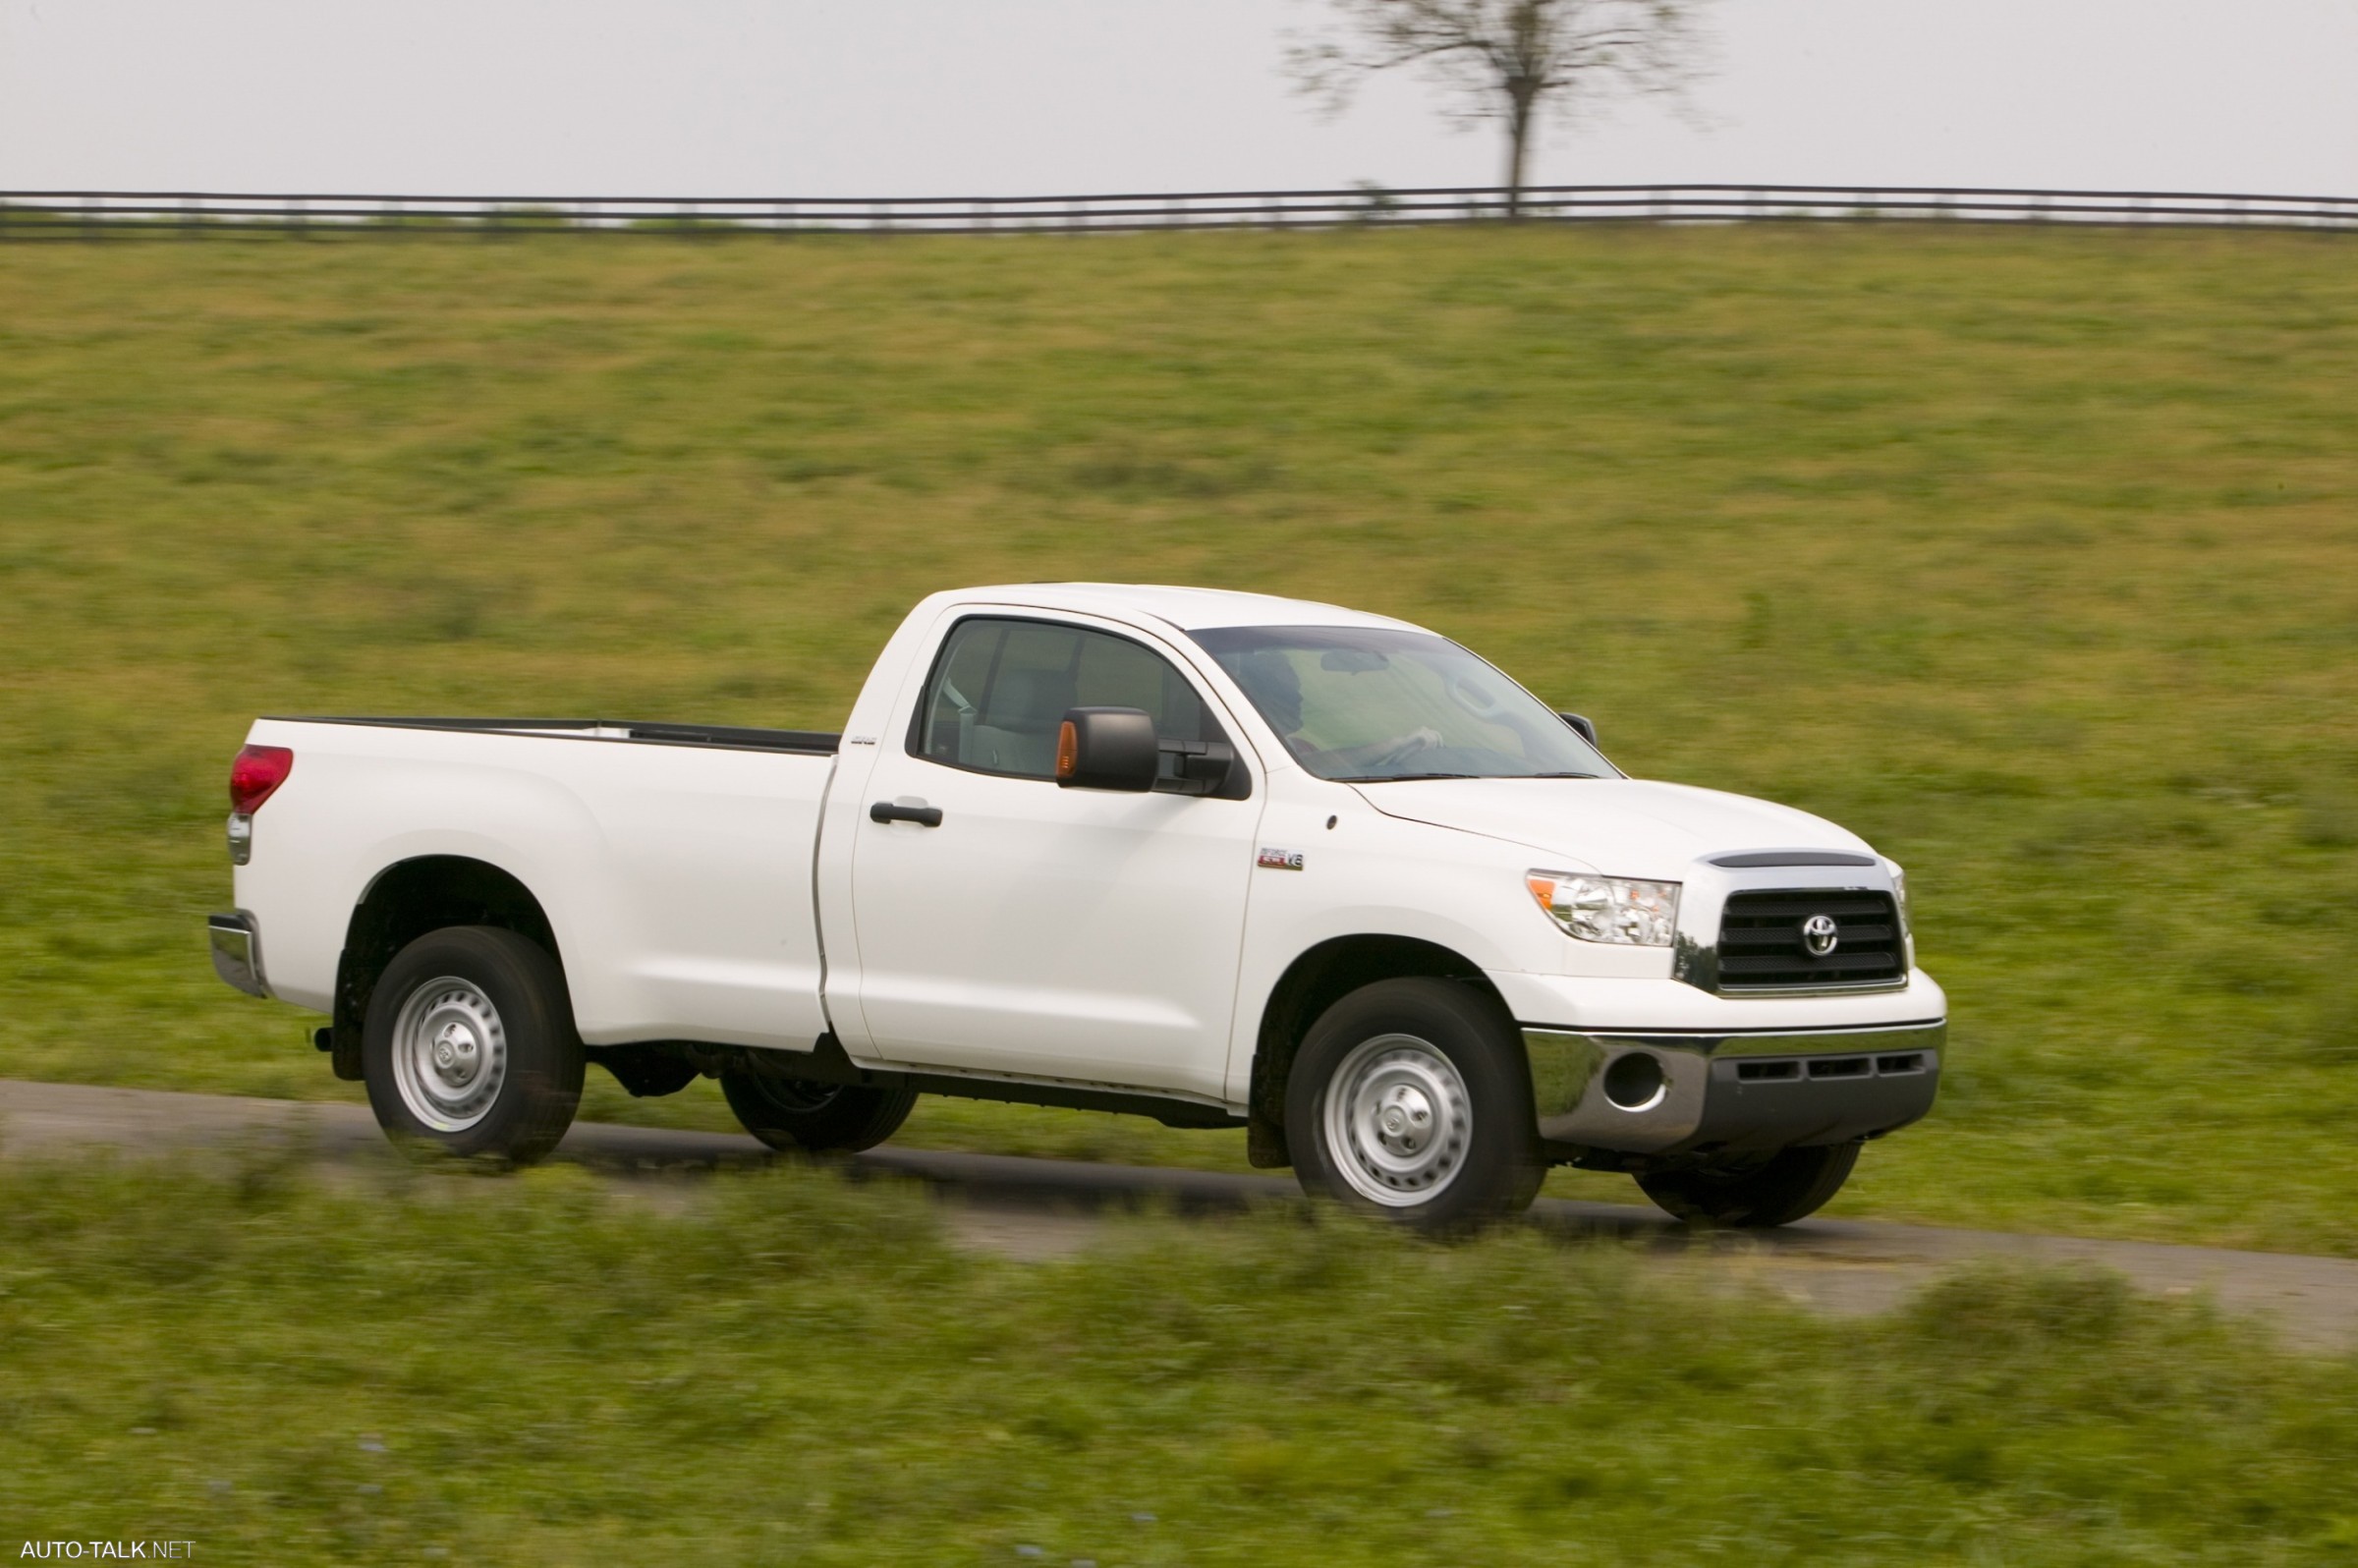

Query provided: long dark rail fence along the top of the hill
[0,184,2358,241]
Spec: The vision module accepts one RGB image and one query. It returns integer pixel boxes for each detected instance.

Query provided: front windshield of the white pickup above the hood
[1193,627,1617,783]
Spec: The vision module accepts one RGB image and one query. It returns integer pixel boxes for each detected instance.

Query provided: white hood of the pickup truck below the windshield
[1354,778,1875,882]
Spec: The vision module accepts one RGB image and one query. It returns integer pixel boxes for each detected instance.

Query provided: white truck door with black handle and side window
[837,613,1263,1096]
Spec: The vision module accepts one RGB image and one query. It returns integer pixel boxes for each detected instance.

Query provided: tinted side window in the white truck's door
[910,618,1226,778]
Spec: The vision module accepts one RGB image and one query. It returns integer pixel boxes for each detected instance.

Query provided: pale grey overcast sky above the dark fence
[0,0,2358,196]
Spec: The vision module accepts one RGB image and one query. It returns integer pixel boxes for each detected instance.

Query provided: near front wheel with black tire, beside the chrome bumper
[1285,979,1546,1233]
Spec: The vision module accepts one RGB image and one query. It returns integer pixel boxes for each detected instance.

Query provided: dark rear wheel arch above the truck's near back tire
[330,854,566,1080]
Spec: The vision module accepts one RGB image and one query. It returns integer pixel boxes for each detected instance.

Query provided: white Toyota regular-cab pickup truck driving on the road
[210,583,1945,1228]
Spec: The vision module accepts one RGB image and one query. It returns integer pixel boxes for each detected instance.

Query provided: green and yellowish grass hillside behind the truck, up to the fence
[0,226,2358,1255]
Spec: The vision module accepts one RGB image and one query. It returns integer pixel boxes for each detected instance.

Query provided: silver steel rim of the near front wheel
[1325,1036,1474,1209]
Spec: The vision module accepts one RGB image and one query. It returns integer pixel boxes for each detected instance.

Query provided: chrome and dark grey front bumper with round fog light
[1523,1019,1947,1155]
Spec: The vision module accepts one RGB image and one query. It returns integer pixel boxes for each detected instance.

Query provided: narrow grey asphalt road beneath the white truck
[18,1080,2358,1349]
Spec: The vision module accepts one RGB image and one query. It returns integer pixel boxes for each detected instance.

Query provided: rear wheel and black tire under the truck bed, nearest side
[361,926,583,1165]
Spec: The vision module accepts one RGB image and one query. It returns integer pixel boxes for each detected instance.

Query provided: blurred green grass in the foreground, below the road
[0,1150,2358,1568]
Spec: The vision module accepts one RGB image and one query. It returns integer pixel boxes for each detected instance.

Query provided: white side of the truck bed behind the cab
[238,717,837,1049]
